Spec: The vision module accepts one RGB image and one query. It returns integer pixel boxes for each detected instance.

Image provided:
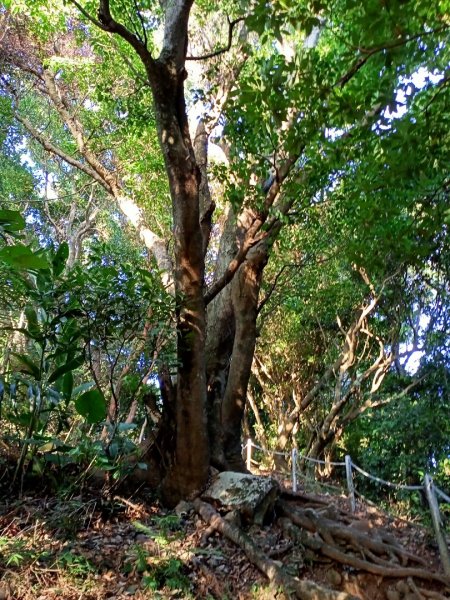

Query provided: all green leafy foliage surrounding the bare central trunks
[0,0,450,506]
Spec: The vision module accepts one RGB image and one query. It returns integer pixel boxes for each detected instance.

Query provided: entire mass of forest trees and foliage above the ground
[0,0,450,508]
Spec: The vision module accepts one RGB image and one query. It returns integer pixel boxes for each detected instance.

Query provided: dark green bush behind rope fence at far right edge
[343,360,450,509]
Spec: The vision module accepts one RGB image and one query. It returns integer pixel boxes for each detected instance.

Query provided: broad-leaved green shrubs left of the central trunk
[0,211,172,486]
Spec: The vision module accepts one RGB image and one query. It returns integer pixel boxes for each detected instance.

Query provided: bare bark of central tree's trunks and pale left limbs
[2,0,298,503]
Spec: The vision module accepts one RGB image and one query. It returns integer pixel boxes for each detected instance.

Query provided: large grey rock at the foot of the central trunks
[202,471,280,525]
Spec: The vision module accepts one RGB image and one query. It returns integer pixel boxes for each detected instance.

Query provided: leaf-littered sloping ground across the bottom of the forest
[0,474,450,600]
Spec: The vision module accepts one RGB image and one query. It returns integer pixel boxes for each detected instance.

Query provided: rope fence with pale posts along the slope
[242,438,450,577]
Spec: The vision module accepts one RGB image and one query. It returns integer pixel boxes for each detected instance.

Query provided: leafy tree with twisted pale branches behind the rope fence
[246,72,449,458]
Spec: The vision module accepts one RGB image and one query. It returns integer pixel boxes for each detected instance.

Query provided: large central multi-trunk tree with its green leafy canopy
[1,0,449,502]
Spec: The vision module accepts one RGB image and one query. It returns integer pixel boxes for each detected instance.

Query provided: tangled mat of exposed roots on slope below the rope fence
[277,500,450,594]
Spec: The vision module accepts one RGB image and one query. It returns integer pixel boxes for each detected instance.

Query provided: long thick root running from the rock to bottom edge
[194,499,357,600]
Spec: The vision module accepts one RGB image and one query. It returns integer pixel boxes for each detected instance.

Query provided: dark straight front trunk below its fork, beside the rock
[149,61,209,504]
